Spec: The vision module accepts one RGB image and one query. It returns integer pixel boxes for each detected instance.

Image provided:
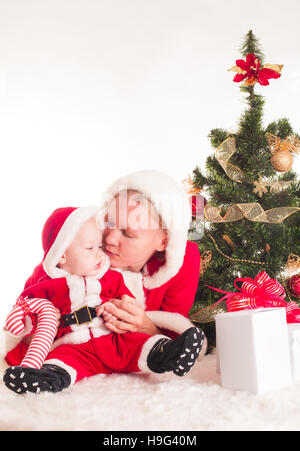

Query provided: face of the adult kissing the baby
[103,191,167,272]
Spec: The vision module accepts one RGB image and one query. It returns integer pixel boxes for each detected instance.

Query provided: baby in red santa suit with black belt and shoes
[3,207,203,394]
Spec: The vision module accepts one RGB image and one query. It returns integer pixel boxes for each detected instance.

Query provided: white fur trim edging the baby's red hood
[43,206,107,279]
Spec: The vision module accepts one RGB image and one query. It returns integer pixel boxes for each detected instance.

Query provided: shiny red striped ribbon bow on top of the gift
[208,271,300,323]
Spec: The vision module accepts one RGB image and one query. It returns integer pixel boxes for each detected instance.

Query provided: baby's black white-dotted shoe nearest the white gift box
[147,327,204,376]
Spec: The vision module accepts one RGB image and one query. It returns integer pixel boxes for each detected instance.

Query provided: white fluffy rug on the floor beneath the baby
[0,355,300,431]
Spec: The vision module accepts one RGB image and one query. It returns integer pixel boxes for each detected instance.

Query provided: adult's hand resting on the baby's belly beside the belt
[97,294,159,335]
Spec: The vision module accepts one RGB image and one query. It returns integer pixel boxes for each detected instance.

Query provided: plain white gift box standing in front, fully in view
[216,308,292,393]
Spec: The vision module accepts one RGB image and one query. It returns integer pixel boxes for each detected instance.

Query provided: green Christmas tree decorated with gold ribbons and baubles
[191,31,300,346]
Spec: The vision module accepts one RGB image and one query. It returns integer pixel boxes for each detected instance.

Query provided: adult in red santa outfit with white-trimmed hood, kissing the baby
[97,171,205,337]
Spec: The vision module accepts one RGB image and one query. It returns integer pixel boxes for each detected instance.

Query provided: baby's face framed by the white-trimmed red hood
[60,218,105,277]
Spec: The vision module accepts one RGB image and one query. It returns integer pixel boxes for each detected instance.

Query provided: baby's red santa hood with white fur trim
[42,206,109,279]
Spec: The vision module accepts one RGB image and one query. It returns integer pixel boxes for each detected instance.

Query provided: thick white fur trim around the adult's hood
[99,170,191,289]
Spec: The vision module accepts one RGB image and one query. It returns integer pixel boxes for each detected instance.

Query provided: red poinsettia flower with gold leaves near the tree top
[229,53,283,86]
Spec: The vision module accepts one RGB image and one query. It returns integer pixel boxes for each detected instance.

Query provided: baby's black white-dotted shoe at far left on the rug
[3,364,71,395]
